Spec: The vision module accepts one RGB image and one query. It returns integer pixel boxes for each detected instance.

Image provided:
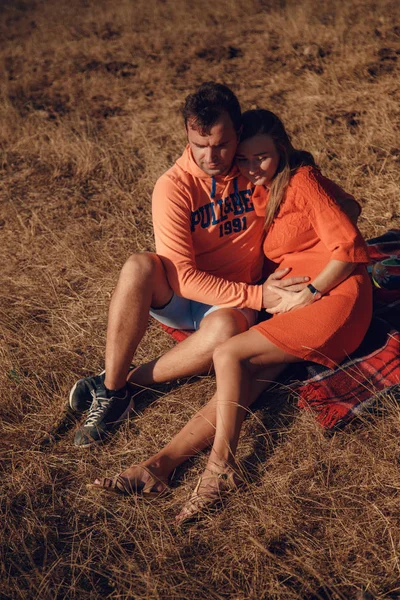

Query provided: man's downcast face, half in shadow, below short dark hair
[187,113,238,177]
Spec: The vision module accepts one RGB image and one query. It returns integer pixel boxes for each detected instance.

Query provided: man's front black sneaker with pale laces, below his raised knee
[74,381,134,448]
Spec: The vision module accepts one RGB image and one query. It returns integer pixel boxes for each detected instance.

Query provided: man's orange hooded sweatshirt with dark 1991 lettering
[152,146,264,310]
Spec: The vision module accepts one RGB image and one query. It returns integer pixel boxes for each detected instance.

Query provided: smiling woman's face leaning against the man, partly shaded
[236,133,280,187]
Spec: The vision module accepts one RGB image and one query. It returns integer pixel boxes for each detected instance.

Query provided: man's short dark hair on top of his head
[182,81,242,134]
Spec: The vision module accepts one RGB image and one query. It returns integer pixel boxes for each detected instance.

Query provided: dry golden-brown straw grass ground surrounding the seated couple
[0,0,400,600]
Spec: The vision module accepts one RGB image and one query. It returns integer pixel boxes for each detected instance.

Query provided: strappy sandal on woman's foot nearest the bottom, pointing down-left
[176,469,243,525]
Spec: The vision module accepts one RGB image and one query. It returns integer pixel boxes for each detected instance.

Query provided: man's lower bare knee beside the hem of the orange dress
[200,308,249,347]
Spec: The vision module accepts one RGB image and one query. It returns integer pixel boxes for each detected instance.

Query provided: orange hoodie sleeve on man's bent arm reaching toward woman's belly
[152,175,262,310]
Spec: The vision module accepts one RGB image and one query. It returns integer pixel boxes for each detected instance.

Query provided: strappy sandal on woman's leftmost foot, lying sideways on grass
[86,466,170,498]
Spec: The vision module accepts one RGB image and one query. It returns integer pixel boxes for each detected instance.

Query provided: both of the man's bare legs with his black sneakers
[74,253,300,447]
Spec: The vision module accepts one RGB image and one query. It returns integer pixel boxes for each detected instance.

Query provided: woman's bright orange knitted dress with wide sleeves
[253,167,372,368]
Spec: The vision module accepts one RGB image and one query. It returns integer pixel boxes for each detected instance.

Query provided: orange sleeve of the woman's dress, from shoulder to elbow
[295,169,369,263]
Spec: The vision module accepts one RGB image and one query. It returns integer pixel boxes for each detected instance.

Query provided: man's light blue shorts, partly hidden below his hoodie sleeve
[150,294,258,330]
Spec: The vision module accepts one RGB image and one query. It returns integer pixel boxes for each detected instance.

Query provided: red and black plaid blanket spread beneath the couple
[162,230,400,430]
